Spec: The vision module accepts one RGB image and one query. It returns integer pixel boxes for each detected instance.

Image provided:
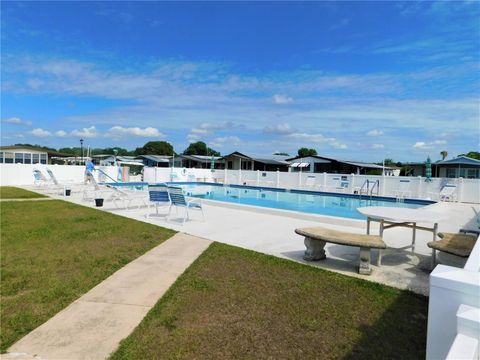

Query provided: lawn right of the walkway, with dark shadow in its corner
[111,243,427,360]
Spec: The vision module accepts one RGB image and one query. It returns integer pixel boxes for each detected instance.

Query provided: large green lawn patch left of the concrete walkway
[0,200,174,352]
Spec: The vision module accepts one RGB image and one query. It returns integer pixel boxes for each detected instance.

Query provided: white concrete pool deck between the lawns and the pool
[29,187,480,295]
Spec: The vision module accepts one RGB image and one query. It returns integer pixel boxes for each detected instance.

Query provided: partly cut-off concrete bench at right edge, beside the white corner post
[427,233,477,268]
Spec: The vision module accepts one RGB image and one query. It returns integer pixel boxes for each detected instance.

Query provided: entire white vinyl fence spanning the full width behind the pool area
[0,164,480,203]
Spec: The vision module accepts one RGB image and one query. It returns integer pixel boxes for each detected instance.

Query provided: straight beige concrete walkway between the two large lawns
[2,233,211,360]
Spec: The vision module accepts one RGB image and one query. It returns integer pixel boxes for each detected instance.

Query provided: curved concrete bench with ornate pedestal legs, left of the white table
[295,227,387,275]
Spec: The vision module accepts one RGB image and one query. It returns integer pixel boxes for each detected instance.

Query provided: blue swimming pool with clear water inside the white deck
[175,183,434,219]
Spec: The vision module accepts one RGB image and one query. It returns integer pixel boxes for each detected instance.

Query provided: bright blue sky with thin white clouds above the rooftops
[1,1,480,161]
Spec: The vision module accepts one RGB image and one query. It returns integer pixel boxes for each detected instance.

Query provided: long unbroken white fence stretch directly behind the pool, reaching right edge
[144,168,480,203]
